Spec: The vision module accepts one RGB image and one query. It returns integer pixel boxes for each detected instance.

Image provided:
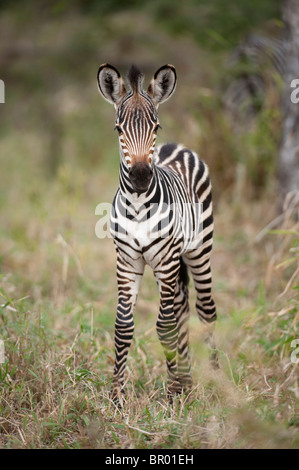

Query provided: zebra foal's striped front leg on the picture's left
[112,256,144,401]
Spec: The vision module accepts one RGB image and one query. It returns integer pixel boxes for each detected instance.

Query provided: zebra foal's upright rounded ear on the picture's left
[98,64,126,107]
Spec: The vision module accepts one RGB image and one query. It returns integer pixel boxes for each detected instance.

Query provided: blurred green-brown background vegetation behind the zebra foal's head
[0,0,281,196]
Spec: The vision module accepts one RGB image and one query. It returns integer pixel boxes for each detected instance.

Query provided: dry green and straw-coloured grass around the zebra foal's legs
[0,182,299,449]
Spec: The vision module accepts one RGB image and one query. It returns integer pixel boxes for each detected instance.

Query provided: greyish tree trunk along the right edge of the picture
[278,0,299,211]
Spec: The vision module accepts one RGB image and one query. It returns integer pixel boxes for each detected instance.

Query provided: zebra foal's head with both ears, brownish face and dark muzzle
[98,64,176,193]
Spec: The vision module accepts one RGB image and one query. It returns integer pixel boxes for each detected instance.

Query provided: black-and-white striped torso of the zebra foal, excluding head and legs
[111,144,213,258]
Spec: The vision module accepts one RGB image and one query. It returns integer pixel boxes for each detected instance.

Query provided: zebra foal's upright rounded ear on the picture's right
[147,64,177,108]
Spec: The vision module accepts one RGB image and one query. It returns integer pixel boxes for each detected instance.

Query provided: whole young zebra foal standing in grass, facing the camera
[98,64,216,399]
